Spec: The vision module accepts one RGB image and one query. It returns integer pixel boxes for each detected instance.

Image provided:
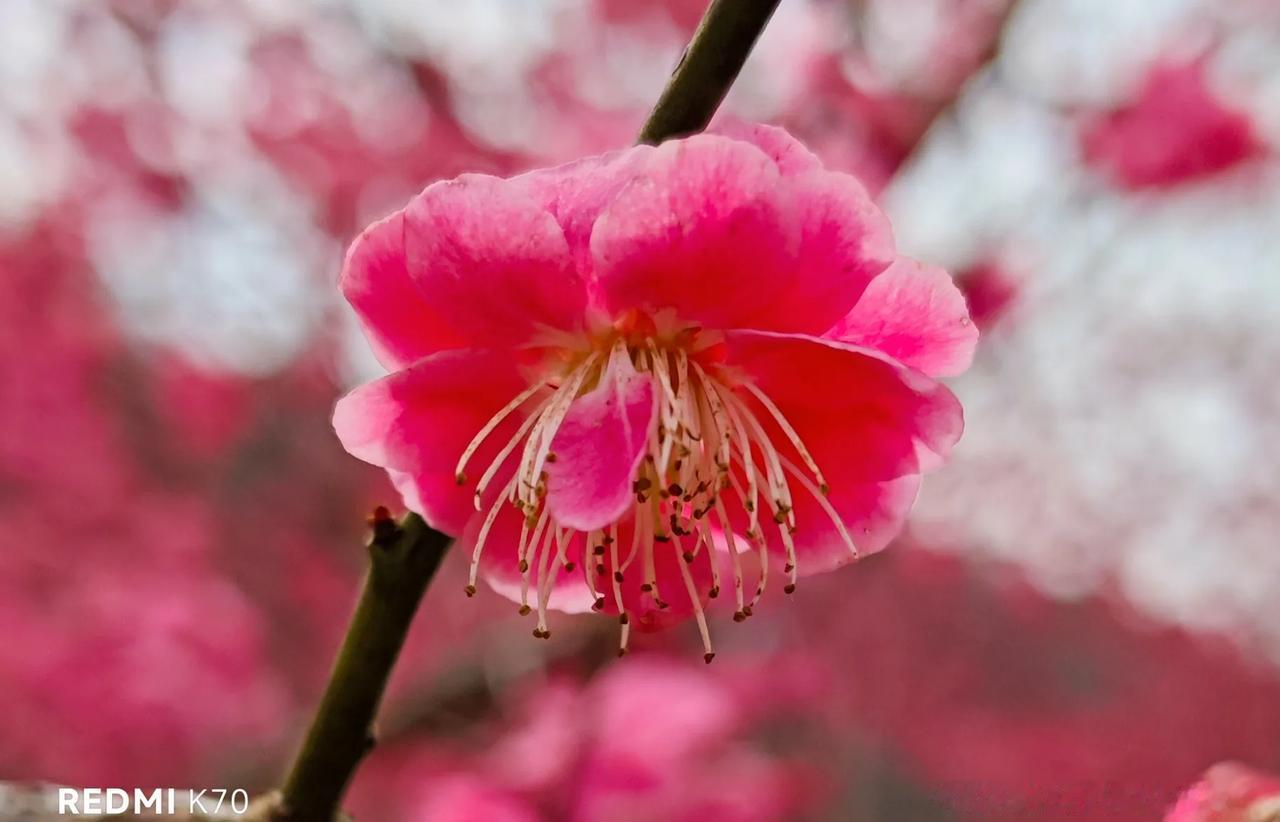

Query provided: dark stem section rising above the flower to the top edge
[639,0,781,146]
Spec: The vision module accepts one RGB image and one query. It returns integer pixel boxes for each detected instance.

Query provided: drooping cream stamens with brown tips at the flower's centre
[457,314,858,662]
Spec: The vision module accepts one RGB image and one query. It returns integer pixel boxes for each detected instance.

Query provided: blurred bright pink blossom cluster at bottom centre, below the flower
[351,654,824,822]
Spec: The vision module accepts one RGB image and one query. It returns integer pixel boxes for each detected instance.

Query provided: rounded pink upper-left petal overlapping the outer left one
[404,174,586,347]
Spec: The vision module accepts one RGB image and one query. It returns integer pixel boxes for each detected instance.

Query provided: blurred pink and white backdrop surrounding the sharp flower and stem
[0,0,1280,822]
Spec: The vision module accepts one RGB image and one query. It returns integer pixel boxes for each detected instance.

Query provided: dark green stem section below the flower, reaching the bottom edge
[273,508,452,822]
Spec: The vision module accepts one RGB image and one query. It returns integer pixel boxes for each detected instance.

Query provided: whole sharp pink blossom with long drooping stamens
[334,125,977,658]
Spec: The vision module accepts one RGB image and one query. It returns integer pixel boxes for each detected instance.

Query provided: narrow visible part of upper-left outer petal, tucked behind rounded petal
[340,211,463,370]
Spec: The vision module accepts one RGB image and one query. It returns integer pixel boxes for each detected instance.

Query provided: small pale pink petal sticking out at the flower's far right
[824,257,978,376]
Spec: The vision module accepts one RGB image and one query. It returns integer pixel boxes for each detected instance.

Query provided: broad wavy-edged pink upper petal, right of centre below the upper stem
[591,134,892,333]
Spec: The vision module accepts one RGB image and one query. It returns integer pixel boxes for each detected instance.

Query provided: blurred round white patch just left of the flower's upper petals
[90,159,340,374]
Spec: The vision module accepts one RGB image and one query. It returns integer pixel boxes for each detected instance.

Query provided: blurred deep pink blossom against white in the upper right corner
[1080,60,1262,188]
